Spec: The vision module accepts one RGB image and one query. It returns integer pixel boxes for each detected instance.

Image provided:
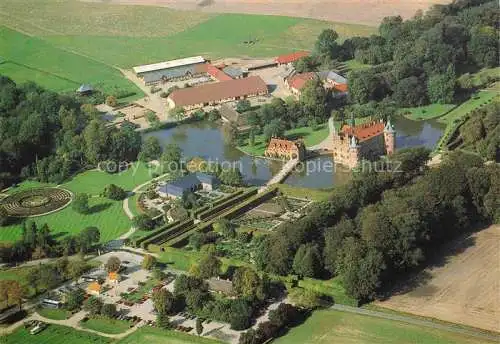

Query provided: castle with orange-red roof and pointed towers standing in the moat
[333,118,396,168]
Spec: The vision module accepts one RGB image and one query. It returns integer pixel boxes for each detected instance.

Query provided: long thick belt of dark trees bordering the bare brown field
[255,148,500,301]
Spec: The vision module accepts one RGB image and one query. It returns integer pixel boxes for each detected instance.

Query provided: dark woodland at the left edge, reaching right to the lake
[0,76,141,189]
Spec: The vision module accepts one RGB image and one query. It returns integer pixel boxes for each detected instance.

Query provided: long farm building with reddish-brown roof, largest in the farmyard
[167,76,268,110]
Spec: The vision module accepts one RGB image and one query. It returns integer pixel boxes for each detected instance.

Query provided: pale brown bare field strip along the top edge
[92,0,451,26]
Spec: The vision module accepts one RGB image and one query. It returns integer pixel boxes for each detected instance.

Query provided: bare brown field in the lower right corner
[377,225,500,332]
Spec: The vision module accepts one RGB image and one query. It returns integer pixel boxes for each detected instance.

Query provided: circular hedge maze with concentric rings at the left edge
[0,188,71,217]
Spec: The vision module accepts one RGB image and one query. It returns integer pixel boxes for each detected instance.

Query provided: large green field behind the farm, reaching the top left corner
[0,0,376,94]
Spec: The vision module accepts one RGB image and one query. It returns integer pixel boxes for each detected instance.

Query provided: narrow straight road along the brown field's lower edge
[331,304,500,342]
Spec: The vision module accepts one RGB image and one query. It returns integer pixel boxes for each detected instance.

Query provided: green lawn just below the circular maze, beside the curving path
[0,197,131,242]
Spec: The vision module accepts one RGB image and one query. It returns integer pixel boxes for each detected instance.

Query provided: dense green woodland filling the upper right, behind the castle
[296,0,500,117]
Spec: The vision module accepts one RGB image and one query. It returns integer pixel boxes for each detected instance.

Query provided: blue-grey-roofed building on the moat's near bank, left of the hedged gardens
[158,172,220,198]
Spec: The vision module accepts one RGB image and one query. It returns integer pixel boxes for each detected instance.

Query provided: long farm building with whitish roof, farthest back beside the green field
[133,56,206,85]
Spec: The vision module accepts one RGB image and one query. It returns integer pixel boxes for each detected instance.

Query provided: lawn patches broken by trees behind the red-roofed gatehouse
[238,124,329,156]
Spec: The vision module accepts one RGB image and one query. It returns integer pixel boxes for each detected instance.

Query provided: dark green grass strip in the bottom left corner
[1,325,112,344]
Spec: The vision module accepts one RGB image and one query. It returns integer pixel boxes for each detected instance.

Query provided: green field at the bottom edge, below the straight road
[273,310,489,344]
